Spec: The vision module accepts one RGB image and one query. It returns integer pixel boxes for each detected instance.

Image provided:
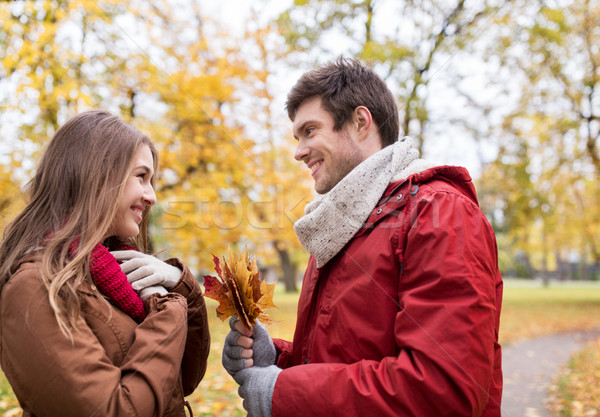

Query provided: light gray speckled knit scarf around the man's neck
[294,136,430,268]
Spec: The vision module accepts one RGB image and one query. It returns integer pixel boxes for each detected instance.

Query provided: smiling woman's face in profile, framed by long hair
[110,145,156,238]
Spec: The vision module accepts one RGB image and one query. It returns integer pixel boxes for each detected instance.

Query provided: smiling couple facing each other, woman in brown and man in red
[0,58,502,417]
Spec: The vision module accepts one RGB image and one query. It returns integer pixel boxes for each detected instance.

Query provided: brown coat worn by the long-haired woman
[0,259,210,417]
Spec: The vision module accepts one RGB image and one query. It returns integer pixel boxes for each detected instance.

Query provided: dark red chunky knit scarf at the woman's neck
[69,240,146,323]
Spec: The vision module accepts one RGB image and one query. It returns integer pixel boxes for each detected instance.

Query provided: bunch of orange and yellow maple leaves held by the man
[204,248,277,330]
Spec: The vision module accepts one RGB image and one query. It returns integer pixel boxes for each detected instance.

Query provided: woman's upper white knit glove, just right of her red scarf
[111,250,181,291]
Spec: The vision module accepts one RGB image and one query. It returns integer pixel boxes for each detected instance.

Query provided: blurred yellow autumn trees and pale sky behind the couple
[0,0,600,291]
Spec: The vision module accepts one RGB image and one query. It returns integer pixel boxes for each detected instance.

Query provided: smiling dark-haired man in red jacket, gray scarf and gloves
[223,58,502,417]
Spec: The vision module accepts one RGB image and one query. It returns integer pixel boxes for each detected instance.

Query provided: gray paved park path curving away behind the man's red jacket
[502,331,600,417]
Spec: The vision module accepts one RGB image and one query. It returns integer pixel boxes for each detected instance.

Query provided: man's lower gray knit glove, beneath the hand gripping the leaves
[234,365,282,417]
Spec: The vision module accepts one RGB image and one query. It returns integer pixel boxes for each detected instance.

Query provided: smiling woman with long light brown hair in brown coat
[0,111,209,416]
